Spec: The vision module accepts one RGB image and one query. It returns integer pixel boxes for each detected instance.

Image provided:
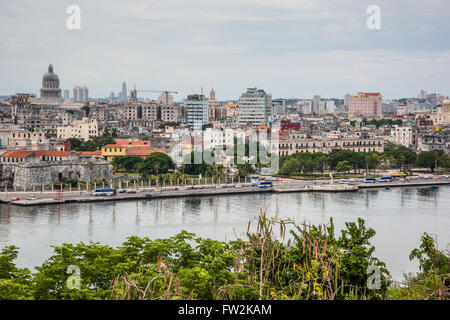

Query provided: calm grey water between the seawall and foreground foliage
[0,186,450,280]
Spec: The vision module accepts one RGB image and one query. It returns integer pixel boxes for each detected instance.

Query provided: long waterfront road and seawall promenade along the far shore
[0,176,450,206]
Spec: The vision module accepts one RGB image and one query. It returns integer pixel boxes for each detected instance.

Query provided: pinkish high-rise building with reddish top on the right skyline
[348,92,383,118]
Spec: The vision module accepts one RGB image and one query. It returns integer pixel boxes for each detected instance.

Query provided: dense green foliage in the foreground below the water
[0,214,450,299]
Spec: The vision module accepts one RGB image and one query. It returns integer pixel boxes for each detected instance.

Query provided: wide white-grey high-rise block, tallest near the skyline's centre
[238,88,273,127]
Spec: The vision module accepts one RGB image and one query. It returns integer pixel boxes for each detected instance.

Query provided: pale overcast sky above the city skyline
[0,0,450,101]
